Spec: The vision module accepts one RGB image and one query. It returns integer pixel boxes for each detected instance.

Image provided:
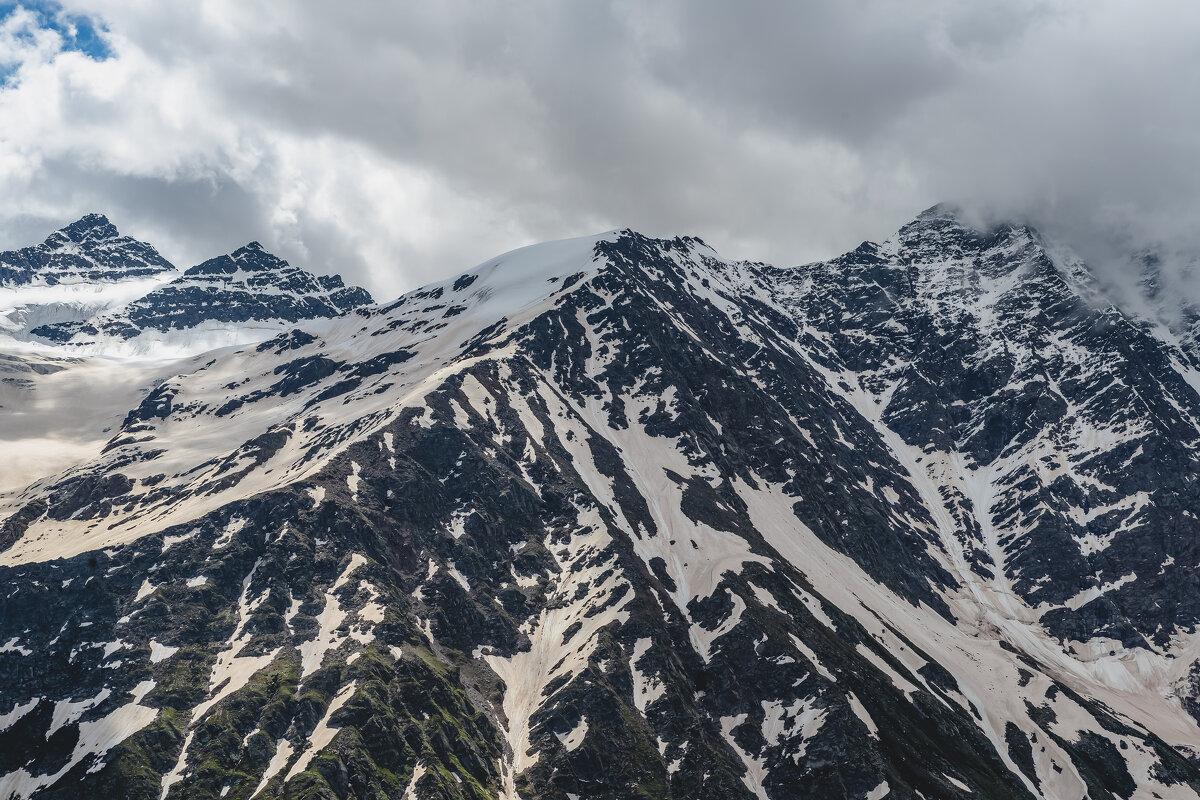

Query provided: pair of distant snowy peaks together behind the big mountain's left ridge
[0,213,372,355]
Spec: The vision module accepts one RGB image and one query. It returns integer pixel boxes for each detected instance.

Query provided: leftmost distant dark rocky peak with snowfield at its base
[0,213,178,338]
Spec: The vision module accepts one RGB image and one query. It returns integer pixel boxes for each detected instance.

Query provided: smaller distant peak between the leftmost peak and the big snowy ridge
[31,242,373,351]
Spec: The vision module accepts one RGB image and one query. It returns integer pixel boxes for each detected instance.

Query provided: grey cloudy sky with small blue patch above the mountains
[0,0,1200,297]
